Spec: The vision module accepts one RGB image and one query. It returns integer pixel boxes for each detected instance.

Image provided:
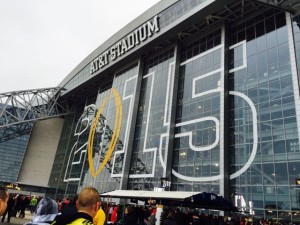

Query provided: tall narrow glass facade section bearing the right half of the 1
[128,48,175,190]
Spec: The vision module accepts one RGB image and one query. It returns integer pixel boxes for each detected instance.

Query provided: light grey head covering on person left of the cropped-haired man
[32,197,58,223]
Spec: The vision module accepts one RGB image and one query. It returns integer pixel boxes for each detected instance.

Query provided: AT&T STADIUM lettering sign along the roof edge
[90,15,159,74]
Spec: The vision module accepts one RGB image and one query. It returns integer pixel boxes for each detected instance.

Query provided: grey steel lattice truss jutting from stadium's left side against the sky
[0,87,69,128]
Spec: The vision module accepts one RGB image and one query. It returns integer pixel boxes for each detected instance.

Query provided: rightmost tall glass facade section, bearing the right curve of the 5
[229,11,300,217]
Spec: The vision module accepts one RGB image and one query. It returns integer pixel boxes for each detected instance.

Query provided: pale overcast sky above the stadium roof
[0,0,159,93]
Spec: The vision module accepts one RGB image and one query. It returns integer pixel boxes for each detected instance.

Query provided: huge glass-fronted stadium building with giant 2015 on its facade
[0,0,300,222]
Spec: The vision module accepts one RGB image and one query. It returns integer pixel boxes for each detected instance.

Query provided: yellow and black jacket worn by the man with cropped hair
[51,212,94,225]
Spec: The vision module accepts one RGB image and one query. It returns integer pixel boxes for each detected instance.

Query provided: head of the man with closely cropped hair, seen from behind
[77,187,100,217]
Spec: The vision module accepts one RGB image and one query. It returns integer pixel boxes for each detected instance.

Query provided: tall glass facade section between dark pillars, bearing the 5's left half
[172,29,224,193]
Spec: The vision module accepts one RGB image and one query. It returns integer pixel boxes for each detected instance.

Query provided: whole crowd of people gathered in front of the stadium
[0,186,290,225]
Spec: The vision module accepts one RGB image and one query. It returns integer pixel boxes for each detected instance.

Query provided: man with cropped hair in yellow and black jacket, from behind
[51,187,100,225]
